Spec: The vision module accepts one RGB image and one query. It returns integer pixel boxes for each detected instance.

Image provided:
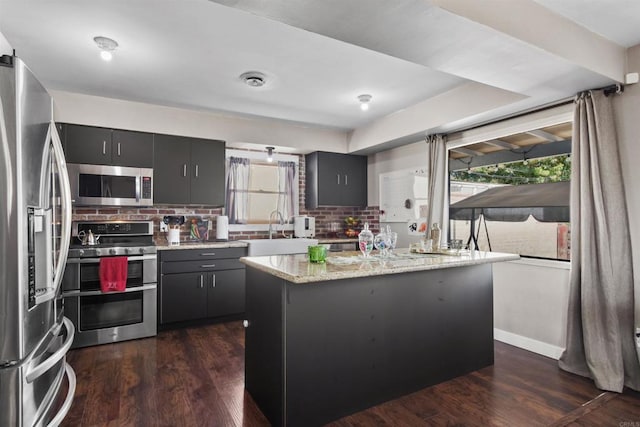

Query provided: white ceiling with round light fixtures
[0,0,640,154]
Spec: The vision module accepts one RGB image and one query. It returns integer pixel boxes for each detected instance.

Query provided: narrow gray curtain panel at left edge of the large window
[426,135,449,246]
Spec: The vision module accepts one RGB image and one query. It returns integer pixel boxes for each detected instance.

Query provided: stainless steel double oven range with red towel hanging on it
[62,221,157,348]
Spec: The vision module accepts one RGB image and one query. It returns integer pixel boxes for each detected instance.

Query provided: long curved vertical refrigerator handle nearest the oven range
[49,120,71,293]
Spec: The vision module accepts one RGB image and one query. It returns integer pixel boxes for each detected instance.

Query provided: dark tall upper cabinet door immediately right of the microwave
[153,135,190,205]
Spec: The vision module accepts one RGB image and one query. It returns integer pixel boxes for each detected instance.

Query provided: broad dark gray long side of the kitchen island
[284,264,493,426]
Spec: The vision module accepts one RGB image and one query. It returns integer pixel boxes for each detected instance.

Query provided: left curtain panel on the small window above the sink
[225,157,251,224]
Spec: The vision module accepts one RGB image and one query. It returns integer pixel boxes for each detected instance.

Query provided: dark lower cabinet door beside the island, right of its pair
[207,268,245,317]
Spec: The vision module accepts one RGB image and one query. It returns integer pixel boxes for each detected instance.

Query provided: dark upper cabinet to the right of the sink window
[305,151,367,209]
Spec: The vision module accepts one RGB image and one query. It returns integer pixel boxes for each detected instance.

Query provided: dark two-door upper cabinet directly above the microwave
[61,124,153,168]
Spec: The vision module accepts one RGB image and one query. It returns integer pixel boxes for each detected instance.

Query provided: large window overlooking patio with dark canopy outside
[449,122,571,260]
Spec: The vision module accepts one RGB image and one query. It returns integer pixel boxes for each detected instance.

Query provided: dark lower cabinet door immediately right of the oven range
[160,273,207,323]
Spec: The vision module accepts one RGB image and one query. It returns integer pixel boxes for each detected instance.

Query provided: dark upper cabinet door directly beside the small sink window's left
[190,138,225,206]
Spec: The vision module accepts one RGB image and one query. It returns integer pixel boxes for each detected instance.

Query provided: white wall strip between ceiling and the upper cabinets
[50,90,347,153]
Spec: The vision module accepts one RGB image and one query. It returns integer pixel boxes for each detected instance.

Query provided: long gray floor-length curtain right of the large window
[560,91,640,392]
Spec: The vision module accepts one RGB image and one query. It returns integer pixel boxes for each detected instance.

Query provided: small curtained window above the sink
[226,150,298,231]
